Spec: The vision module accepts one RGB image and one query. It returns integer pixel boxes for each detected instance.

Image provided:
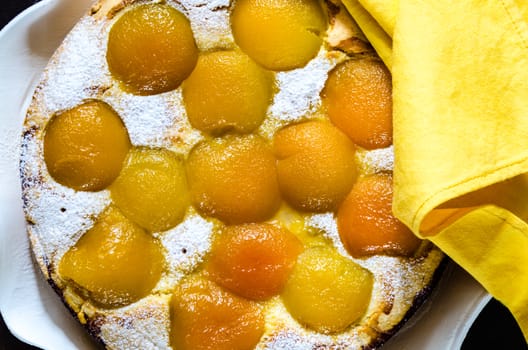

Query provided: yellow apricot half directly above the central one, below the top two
[183,51,273,133]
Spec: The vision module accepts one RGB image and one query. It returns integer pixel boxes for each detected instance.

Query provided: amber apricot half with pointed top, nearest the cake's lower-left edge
[59,207,164,307]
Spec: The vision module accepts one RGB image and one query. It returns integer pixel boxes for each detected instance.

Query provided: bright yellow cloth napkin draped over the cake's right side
[343,0,528,342]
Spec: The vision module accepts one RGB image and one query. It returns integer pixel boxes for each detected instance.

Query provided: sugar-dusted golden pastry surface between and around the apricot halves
[21,0,443,349]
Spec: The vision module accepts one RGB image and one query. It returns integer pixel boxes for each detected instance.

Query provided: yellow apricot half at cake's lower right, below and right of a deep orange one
[282,247,373,333]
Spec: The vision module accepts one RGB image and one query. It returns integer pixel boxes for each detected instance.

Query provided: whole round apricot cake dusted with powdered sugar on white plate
[20,0,443,349]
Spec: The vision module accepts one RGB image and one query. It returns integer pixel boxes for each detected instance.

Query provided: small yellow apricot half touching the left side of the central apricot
[110,148,190,232]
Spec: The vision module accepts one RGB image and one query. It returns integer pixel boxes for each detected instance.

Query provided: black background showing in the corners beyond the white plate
[0,0,528,350]
